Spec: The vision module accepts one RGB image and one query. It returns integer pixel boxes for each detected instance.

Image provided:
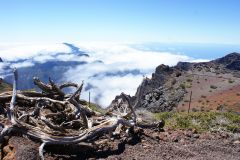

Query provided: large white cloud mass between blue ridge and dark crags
[65,43,206,106]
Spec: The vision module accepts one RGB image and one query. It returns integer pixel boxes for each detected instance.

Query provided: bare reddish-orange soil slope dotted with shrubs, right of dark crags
[177,73,240,113]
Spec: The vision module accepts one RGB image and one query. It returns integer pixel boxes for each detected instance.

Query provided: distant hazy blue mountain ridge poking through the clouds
[3,43,89,90]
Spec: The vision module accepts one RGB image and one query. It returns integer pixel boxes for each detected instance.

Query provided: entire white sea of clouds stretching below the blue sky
[0,43,207,107]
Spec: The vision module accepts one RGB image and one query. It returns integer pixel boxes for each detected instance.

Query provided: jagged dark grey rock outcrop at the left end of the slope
[110,64,185,112]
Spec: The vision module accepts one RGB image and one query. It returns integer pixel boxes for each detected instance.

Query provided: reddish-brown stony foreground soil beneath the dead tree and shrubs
[0,130,240,160]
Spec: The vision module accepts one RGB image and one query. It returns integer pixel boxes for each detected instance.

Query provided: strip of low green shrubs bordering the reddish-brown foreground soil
[155,110,240,132]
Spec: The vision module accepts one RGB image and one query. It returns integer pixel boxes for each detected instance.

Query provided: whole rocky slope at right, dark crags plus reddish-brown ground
[110,53,240,112]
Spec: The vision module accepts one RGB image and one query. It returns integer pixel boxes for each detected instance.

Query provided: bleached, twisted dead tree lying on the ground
[0,69,162,159]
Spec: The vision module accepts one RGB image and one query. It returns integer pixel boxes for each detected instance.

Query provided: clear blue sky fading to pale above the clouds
[0,0,240,44]
